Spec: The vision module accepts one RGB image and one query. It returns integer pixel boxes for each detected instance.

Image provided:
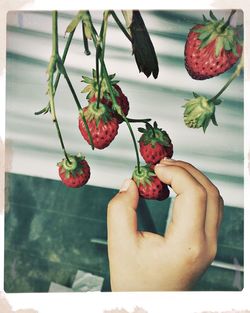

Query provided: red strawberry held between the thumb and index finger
[132,164,169,201]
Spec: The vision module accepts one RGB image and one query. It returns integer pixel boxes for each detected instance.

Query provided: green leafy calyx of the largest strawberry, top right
[193,11,242,57]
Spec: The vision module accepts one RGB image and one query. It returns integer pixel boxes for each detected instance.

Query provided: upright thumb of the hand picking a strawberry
[107,179,139,247]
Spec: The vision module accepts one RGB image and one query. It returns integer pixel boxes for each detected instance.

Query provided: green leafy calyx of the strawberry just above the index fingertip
[138,122,171,148]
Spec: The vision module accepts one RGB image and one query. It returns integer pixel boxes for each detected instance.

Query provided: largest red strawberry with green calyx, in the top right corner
[185,11,242,80]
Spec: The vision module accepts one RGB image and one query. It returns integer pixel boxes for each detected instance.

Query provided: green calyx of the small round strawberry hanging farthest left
[57,153,85,179]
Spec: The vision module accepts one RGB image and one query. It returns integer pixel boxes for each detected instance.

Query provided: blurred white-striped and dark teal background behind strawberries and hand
[4,10,244,292]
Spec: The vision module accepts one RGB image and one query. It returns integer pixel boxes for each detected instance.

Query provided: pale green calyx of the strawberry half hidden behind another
[81,69,119,101]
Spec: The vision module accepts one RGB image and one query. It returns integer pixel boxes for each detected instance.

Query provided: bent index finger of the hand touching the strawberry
[155,164,207,236]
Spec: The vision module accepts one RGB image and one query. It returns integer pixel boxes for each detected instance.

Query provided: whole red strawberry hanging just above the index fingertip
[138,122,173,164]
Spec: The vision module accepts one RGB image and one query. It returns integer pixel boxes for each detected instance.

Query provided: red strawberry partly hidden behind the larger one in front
[82,70,129,123]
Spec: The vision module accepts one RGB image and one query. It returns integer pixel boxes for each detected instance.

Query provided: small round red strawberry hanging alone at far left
[57,154,90,188]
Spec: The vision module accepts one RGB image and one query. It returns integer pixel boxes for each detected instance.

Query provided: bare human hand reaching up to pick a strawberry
[108,159,223,291]
